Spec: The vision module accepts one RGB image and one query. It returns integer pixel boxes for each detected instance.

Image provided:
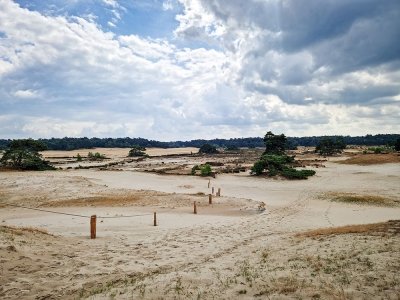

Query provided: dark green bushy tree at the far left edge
[0,139,54,171]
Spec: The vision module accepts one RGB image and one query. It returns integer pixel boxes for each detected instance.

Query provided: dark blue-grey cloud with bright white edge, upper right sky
[176,0,400,103]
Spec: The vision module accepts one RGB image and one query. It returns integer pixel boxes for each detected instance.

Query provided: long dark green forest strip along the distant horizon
[0,134,400,150]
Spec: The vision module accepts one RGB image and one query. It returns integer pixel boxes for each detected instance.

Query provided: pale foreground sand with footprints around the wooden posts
[0,151,400,299]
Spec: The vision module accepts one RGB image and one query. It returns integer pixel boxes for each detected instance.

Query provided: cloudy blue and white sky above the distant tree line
[0,0,400,141]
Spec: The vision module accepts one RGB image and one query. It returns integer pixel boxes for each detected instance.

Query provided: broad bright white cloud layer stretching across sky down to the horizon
[0,0,400,140]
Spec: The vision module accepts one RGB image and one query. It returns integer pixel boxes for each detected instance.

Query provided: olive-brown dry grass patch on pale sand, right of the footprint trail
[322,192,399,206]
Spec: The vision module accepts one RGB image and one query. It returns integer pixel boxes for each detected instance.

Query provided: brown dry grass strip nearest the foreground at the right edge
[296,220,400,237]
